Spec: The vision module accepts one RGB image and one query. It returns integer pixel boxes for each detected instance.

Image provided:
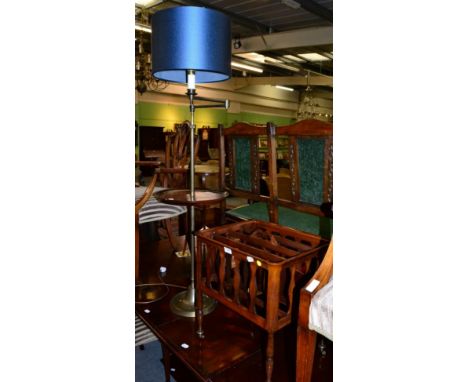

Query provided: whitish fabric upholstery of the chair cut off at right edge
[309,276,333,341]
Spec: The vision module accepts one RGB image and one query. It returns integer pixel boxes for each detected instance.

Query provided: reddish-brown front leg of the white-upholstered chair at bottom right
[296,326,317,382]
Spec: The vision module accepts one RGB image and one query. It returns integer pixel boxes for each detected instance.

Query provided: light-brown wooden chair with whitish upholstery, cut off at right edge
[296,241,333,382]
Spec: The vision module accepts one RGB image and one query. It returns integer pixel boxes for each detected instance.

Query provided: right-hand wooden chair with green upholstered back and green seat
[268,119,333,238]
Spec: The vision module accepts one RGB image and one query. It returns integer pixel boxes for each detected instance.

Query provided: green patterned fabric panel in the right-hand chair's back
[297,138,325,205]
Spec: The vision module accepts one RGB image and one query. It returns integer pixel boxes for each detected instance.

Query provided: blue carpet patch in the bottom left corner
[135,341,175,382]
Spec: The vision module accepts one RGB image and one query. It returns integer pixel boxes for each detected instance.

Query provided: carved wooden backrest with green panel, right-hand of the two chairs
[269,119,333,216]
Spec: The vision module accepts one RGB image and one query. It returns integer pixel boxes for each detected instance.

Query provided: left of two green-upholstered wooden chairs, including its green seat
[219,123,276,221]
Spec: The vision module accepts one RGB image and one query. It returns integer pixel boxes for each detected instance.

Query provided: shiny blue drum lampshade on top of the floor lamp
[151,6,231,83]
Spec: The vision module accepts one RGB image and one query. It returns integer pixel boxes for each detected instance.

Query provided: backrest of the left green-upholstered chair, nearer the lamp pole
[219,123,276,213]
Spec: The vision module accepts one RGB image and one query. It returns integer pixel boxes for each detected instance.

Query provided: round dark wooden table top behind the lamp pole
[154,189,229,206]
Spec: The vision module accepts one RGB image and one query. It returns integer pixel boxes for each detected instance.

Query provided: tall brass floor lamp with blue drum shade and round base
[151,6,231,317]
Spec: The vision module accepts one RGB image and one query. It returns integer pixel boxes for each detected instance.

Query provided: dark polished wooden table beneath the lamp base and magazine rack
[137,296,262,382]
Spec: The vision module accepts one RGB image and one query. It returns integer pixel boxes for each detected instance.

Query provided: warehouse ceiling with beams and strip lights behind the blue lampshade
[135,0,333,90]
